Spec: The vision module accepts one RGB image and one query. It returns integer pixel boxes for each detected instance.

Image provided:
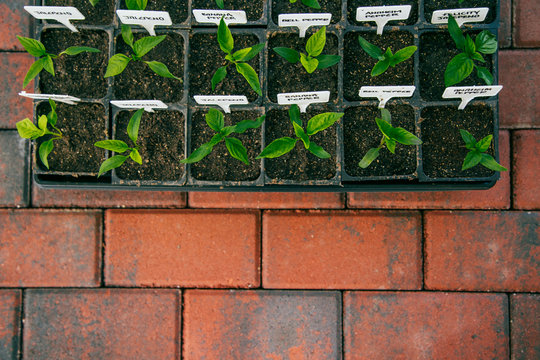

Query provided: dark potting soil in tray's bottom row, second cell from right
[343,105,416,176]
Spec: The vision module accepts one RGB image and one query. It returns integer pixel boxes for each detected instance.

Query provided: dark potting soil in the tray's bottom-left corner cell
[36,102,108,174]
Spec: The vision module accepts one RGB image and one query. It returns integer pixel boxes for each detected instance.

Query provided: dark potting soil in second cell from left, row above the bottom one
[113,32,185,103]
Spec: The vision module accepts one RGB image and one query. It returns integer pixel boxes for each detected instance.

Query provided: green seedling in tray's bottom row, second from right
[358,109,422,169]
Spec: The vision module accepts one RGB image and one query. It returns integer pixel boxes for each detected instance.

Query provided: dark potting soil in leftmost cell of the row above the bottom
[39,29,109,99]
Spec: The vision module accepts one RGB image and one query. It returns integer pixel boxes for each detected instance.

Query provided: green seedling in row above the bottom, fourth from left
[273,26,341,74]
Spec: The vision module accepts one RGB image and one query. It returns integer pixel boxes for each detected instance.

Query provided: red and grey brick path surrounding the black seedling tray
[0,0,540,360]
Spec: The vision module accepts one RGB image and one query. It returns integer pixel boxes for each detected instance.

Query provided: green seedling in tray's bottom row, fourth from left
[257,104,343,159]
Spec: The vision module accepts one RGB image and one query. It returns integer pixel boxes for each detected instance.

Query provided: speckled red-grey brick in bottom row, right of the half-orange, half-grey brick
[343,292,509,360]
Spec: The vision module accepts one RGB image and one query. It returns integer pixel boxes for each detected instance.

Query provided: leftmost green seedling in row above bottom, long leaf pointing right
[17,36,100,88]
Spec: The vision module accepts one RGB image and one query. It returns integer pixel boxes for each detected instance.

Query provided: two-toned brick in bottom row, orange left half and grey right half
[183,290,341,360]
